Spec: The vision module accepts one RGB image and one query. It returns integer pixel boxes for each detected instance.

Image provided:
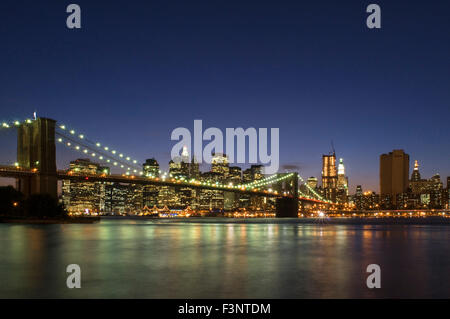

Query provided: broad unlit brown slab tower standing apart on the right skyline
[380,150,409,204]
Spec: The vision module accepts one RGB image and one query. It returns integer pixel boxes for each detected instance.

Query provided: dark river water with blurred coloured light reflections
[0,219,450,298]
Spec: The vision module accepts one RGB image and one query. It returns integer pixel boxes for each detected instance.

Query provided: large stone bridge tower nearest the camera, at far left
[17,118,58,198]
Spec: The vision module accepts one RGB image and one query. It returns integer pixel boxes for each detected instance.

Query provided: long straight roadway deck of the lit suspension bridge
[0,166,324,203]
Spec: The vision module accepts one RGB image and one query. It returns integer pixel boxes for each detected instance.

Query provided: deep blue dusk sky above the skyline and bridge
[0,0,450,192]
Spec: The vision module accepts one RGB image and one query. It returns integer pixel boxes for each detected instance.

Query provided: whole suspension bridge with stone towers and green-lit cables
[0,117,334,217]
